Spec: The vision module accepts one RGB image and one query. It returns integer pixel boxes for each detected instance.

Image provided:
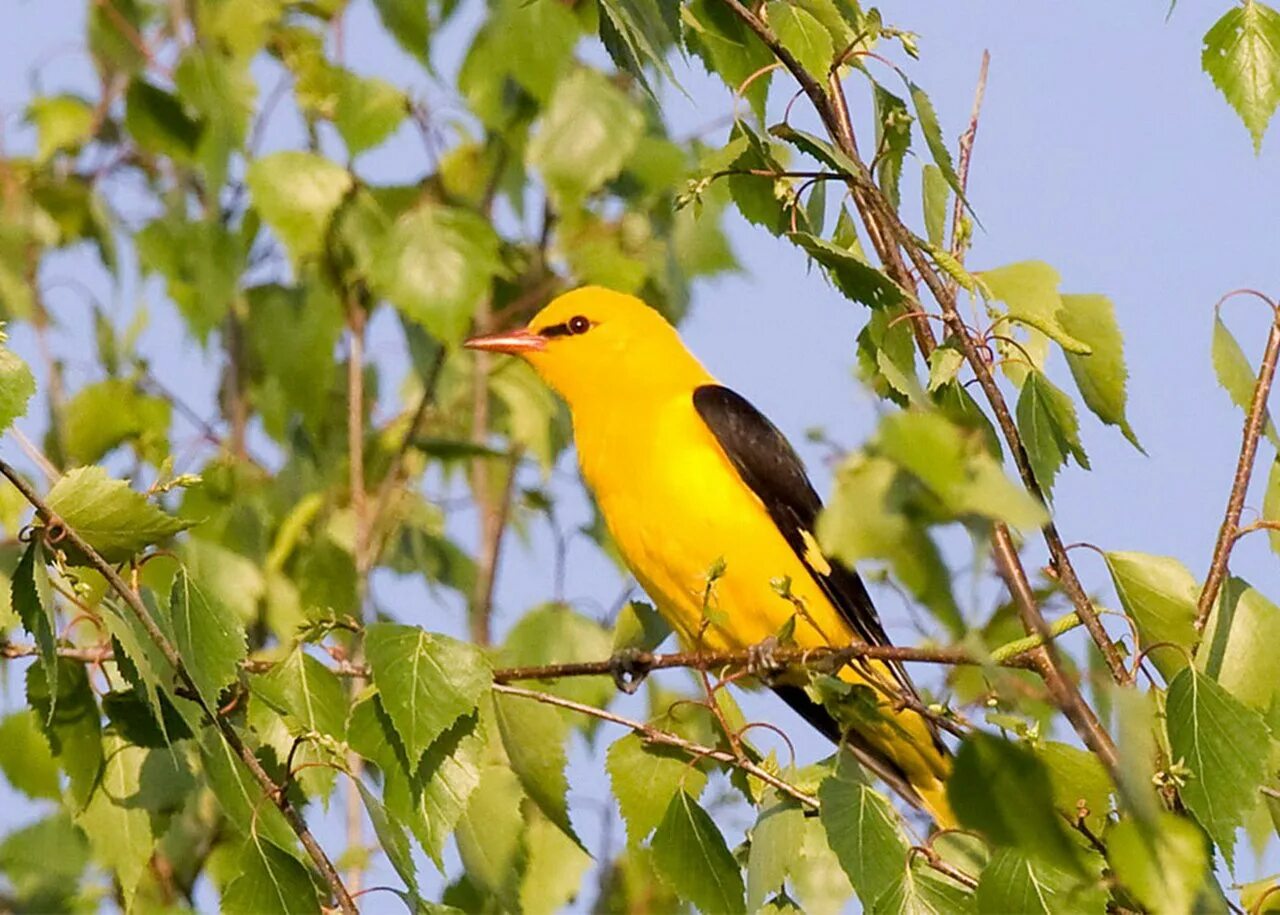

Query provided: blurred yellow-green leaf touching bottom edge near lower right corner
[1107,811,1210,915]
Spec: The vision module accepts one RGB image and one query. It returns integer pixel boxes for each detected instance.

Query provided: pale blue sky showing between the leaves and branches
[0,0,1280,911]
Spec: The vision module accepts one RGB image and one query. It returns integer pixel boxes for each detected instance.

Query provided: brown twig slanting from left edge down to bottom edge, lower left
[0,461,357,915]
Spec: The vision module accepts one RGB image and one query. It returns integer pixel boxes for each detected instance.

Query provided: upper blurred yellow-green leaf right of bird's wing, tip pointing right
[877,411,1048,530]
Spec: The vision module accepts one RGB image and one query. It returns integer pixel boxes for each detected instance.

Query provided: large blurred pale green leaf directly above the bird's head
[525,69,644,211]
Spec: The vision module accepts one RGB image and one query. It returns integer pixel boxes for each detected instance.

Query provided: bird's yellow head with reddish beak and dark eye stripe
[466,285,709,410]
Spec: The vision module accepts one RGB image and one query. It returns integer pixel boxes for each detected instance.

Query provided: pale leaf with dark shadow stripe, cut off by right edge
[1196,576,1280,713]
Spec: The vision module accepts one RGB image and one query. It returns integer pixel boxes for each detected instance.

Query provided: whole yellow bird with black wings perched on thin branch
[466,287,955,828]
